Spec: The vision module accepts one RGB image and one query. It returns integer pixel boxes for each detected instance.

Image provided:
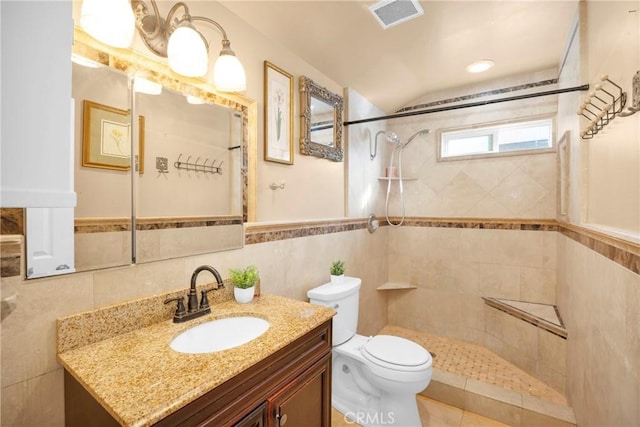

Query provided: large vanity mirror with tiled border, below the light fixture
[72,29,255,271]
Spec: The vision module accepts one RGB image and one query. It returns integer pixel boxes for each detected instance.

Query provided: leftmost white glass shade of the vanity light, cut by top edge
[80,0,135,47]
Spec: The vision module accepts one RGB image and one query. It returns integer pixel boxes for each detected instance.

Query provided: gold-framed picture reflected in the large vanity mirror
[82,100,144,173]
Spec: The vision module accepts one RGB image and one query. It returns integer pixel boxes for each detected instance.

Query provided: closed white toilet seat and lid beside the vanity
[362,335,432,371]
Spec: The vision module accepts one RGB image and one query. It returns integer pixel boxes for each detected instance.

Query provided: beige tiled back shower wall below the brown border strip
[388,223,557,345]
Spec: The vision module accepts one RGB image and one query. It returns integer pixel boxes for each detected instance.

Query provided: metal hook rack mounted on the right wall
[577,74,640,139]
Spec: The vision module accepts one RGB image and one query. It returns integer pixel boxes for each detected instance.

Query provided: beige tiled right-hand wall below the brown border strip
[558,235,640,427]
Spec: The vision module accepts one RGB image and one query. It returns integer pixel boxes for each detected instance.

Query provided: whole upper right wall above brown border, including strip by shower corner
[558,1,640,237]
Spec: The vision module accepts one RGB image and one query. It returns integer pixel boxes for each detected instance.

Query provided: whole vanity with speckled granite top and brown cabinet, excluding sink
[58,295,335,427]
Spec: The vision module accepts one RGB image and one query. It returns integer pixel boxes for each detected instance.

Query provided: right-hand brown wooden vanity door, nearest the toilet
[267,354,331,427]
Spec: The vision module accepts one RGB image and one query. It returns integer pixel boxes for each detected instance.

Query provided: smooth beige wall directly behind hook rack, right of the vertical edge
[581,0,640,236]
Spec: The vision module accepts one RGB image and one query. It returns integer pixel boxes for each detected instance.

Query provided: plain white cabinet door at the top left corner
[0,0,76,208]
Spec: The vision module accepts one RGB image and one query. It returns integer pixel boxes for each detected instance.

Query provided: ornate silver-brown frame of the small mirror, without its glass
[299,76,344,162]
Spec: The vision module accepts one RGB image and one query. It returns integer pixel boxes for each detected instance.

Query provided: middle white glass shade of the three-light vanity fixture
[167,24,209,77]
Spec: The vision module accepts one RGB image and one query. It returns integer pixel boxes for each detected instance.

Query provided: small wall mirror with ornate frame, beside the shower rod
[300,76,344,162]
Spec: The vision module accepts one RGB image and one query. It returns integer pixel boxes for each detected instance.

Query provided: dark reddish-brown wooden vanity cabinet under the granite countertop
[65,320,331,427]
